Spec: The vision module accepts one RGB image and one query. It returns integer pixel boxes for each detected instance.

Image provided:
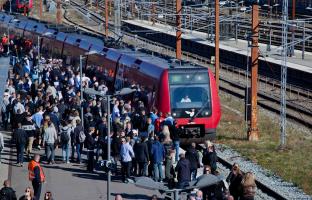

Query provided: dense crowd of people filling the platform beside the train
[0,33,255,200]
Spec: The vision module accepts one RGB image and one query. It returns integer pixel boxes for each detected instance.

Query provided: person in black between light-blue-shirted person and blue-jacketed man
[133,137,149,176]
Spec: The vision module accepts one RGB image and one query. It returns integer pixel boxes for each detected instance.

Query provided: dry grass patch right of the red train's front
[218,92,312,195]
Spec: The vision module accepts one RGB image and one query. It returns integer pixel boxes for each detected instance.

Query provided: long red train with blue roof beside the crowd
[0,13,221,143]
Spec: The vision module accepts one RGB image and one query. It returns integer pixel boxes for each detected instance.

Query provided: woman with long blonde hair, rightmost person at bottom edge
[239,172,257,200]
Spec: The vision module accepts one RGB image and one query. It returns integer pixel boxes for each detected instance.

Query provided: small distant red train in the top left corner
[3,0,33,15]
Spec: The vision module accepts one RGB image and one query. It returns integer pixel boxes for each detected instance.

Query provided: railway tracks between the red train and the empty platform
[61,1,312,127]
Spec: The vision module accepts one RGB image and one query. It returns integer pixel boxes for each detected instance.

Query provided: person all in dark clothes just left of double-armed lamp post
[85,126,98,173]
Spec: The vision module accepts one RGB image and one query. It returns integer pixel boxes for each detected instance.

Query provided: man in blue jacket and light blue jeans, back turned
[151,136,166,182]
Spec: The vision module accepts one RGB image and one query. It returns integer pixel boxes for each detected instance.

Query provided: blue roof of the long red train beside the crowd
[0,13,211,78]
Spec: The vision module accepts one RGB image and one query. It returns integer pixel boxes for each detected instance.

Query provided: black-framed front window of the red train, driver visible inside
[169,70,211,118]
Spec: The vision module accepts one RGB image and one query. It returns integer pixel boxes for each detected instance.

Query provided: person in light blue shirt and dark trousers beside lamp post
[120,138,134,183]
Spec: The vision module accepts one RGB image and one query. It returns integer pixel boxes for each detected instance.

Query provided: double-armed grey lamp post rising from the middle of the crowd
[83,88,135,199]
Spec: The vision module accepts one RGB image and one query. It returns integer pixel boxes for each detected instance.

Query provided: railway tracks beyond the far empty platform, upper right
[93,0,312,52]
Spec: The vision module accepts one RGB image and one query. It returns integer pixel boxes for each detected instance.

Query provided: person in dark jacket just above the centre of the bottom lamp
[175,154,191,189]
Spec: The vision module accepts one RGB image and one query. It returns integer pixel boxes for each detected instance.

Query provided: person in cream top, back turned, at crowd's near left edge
[43,121,57,164]
